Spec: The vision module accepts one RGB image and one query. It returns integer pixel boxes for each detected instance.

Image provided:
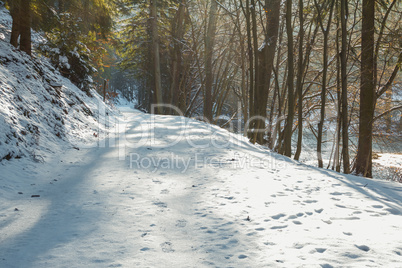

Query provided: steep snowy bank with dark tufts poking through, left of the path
[0,13,116,161]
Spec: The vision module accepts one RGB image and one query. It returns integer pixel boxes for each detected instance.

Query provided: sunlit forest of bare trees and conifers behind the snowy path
[5,0,402,177]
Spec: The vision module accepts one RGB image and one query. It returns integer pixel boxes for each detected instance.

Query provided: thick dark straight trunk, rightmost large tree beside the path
[356,0,375,178]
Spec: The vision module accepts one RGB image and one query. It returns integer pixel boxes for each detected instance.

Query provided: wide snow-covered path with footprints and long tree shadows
[0,109,402,267]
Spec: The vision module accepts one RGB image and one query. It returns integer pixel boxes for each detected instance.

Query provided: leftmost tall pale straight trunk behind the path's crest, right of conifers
[149,0,163,114]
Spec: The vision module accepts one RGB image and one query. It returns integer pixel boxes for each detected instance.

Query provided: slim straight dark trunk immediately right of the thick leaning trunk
[284,0,295,157]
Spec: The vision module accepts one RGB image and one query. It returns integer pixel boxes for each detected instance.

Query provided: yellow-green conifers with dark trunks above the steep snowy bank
[7,0,113,93]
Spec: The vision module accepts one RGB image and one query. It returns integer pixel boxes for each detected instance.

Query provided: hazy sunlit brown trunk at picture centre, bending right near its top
[204,0,218,122]
